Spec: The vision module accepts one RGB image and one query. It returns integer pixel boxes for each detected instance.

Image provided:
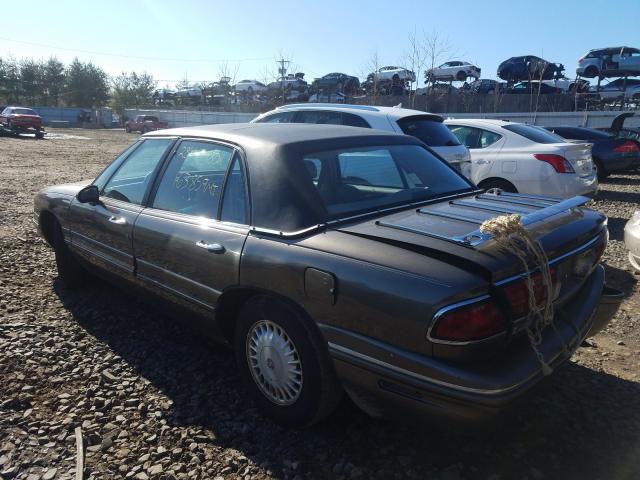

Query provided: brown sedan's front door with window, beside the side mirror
[69,139,174,276]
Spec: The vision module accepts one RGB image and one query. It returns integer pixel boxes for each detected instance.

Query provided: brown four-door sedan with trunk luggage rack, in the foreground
[35,124,608,426]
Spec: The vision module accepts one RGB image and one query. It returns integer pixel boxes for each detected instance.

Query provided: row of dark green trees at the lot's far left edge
[0,57,156,113]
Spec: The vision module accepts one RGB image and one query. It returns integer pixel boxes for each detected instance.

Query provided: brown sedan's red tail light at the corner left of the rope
[429,299,506,342]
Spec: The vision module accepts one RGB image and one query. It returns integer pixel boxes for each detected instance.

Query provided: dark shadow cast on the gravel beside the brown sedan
[55,281,640,480]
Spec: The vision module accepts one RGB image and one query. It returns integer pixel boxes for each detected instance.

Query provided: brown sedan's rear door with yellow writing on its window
[134,140,249,311]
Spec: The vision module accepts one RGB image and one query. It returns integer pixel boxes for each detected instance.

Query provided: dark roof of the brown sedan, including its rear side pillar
[148,123,424,232]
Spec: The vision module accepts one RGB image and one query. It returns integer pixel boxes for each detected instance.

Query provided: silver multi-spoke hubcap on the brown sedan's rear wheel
[246,320,302,405]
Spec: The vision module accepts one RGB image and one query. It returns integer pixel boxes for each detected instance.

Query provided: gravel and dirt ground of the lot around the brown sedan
[0,130,640,480]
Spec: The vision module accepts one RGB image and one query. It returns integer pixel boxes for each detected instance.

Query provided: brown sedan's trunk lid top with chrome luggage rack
[338,192,606,282]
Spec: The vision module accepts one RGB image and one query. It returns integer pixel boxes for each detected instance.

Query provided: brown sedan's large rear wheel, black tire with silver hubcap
[234,295,342,427]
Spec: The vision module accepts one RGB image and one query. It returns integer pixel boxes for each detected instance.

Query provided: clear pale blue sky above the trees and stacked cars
[0,0,640,87]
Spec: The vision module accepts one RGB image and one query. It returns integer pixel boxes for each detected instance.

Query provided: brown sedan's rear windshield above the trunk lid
[303,142,475,219]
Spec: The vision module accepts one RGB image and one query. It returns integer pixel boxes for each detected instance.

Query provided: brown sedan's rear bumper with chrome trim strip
[325,266,604,422]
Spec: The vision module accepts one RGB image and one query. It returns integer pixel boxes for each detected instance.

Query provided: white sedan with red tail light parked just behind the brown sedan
[445,119,598,198]
